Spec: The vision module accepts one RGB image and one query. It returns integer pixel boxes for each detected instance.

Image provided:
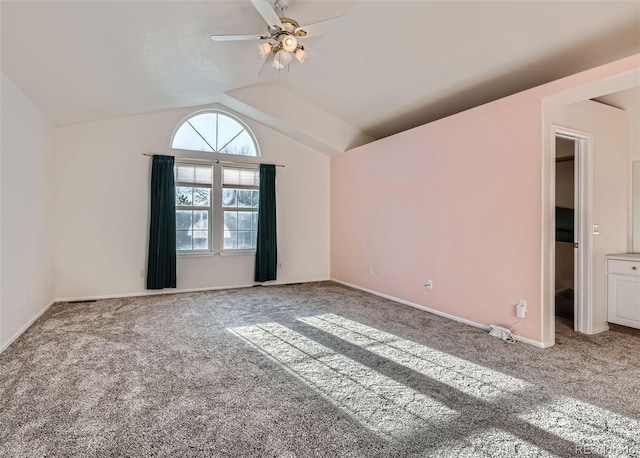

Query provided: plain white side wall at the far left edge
[0,73,55,351]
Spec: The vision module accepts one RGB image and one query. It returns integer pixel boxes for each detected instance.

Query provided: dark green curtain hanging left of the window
[147,155,176,289]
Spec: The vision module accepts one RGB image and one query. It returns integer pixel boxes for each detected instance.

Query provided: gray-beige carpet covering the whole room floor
[0,282,640,457]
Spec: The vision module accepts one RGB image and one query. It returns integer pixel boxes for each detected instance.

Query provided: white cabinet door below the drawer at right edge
[607,274,640,329]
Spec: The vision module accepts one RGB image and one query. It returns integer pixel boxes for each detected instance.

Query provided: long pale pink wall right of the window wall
[331,56,640,342]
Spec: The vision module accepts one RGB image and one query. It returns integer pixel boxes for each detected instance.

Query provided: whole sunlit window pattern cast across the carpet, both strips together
[230,313,640,456]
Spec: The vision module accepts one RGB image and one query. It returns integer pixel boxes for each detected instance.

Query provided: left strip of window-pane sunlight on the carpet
[230,323,459,440]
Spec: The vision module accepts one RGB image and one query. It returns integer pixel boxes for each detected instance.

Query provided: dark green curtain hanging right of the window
[255,164,278,282]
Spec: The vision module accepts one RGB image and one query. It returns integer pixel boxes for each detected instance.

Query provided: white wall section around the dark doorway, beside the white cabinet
[549,100,630,330]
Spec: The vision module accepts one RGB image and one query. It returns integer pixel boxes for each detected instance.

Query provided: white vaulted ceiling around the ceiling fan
[1,0,640,147]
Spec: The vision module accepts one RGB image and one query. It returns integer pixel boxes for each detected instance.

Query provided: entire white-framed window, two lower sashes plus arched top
[171,110,260,254]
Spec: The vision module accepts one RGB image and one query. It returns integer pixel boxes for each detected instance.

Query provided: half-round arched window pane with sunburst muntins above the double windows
[171,110,259,156]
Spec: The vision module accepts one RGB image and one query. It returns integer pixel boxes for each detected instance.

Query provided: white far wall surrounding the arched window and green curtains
[55,105,329,298]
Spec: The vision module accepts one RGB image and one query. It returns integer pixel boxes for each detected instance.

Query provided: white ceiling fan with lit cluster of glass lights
[211,0,344,74]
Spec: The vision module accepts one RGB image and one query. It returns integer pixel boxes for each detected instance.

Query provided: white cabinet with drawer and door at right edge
[607,254,640,329]
